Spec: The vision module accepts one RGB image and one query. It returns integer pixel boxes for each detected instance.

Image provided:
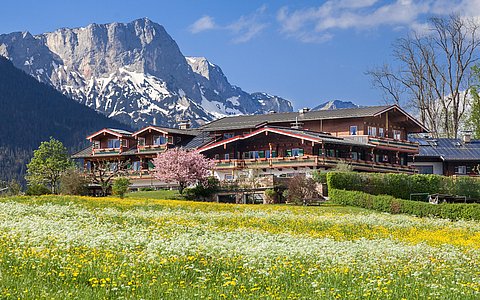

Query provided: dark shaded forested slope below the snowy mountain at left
[0,56,129,183]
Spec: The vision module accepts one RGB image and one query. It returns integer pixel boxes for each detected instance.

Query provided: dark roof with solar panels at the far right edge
[410,138,480,162]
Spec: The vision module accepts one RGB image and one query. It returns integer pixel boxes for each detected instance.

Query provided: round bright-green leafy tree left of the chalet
[26,137,74,194]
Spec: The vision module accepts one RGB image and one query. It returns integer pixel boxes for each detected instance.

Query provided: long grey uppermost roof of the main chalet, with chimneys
[200,105,427,131]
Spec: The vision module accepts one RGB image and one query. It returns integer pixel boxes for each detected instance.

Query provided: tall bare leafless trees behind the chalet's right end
[367,15,480,138]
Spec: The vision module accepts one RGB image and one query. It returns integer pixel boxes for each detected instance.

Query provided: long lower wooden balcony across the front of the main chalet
[215,155,417,174]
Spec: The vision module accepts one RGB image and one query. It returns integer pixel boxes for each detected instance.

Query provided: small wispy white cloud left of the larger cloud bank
[189,5,268,43]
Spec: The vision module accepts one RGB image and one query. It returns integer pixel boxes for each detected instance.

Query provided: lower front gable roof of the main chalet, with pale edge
[198,126,373,152]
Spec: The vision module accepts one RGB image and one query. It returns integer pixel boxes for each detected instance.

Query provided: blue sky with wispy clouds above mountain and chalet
[0,0,480,109]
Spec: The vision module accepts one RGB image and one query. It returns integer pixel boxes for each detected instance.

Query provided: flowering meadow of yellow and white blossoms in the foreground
[0,193,480,299]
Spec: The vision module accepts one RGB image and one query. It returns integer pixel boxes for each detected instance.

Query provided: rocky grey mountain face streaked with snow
[0,19,292,127]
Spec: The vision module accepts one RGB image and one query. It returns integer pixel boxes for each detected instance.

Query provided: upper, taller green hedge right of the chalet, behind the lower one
[327,172,480,200]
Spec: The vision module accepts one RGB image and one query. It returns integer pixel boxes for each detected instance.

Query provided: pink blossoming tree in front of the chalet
[153,148,214,194]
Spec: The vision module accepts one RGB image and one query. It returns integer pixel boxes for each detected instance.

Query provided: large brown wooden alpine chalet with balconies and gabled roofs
[75,105,426,186]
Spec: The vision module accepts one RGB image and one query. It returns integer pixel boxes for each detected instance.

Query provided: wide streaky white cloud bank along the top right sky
[277,0,480,42]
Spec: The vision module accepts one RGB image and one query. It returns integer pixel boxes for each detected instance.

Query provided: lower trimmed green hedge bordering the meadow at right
[329,189,480,220]
